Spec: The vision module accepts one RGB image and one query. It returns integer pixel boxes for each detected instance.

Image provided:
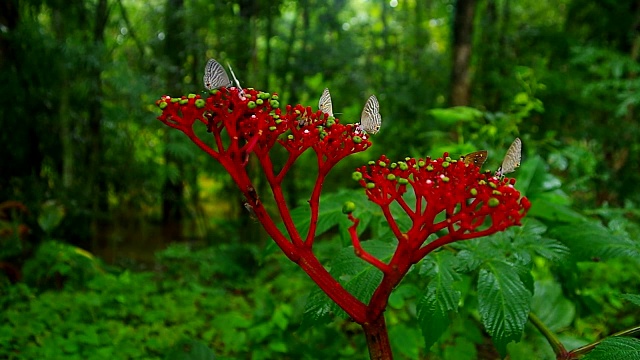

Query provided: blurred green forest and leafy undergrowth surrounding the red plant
[0,0,640,359]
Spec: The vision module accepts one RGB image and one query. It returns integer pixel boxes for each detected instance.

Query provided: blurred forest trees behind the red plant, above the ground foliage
[0,0,640,358]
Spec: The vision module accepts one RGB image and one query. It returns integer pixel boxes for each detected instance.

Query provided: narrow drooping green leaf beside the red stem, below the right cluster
[416,251,460,349]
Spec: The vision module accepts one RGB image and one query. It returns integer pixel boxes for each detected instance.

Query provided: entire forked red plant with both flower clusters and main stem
[157,87,530,358]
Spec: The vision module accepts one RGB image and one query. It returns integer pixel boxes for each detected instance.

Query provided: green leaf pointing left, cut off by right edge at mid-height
[550,221,640,261]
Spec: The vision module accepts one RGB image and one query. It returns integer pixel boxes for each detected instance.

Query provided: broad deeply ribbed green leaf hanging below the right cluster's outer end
[478,262,532,357]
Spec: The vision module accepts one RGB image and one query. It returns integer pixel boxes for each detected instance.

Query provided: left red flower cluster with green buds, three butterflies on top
[156,87,371,170]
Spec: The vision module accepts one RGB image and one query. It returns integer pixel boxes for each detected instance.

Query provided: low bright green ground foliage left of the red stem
[0,246,364,359]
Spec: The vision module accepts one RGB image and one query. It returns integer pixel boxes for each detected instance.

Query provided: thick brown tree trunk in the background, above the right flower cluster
[450,0,476,106]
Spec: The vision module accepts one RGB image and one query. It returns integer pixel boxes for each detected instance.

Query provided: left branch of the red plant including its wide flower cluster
[156,87,371,323]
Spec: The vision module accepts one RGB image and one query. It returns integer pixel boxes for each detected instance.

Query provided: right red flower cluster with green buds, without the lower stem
[353,153,531,261]
